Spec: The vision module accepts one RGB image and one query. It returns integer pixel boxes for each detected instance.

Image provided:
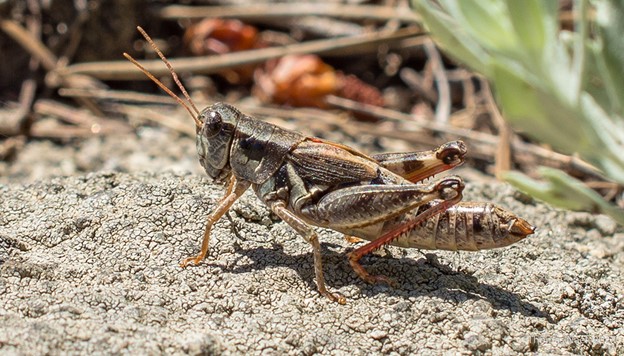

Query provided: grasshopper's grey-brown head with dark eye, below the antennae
[195,103,242,180]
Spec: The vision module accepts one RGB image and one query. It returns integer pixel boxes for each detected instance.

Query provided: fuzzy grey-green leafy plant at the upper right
[413,0,624,224]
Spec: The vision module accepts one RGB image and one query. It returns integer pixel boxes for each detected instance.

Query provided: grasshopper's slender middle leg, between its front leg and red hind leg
[270,201,346,304]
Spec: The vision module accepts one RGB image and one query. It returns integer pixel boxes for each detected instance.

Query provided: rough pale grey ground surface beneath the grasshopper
[0,129,624,355]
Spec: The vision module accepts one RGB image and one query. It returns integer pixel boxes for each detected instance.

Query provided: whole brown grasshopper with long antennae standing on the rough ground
[124,27,535,304]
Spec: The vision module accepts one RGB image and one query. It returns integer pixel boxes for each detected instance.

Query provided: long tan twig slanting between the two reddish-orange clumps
[63,28,423,80]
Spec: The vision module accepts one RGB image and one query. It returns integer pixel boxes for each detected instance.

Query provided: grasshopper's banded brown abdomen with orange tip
[383,202,535,251]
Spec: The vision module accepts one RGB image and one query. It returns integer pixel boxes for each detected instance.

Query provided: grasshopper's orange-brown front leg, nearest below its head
[180,176,251,268]
